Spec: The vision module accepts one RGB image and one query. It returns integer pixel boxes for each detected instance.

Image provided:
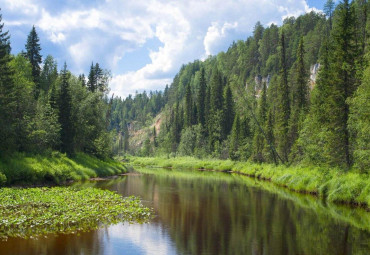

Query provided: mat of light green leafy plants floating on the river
[0,187,152,240]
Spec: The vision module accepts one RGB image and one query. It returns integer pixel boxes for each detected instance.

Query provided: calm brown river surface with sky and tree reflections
[0,168,370,255]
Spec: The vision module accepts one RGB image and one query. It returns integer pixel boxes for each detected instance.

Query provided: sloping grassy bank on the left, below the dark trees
[0,152,126,186]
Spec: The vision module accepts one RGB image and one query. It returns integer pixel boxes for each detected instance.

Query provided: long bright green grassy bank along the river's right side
[130,157,370,209]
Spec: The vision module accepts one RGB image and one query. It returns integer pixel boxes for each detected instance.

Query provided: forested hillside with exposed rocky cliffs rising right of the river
[111,0,370,171]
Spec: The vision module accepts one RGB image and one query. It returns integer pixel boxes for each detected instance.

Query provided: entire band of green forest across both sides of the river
[0,0,370,172]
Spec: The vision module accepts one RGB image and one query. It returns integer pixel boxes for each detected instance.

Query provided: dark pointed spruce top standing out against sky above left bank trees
[26,26,42,97]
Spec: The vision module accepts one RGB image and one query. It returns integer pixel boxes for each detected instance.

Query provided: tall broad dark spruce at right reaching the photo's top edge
[329,0,359,166]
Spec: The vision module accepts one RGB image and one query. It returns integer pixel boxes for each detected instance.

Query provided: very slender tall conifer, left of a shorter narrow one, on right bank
[276,31,290,161]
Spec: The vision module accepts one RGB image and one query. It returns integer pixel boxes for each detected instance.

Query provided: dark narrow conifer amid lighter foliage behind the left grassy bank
[59,63,74,156]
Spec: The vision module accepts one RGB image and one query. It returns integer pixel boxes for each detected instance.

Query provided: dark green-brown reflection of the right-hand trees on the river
[117,169,370,254]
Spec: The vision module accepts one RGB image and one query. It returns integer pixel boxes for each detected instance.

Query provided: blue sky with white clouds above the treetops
[0,0,326,97]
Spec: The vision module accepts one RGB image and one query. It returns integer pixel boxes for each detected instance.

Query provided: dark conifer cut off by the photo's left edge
[0,9,15,152]
